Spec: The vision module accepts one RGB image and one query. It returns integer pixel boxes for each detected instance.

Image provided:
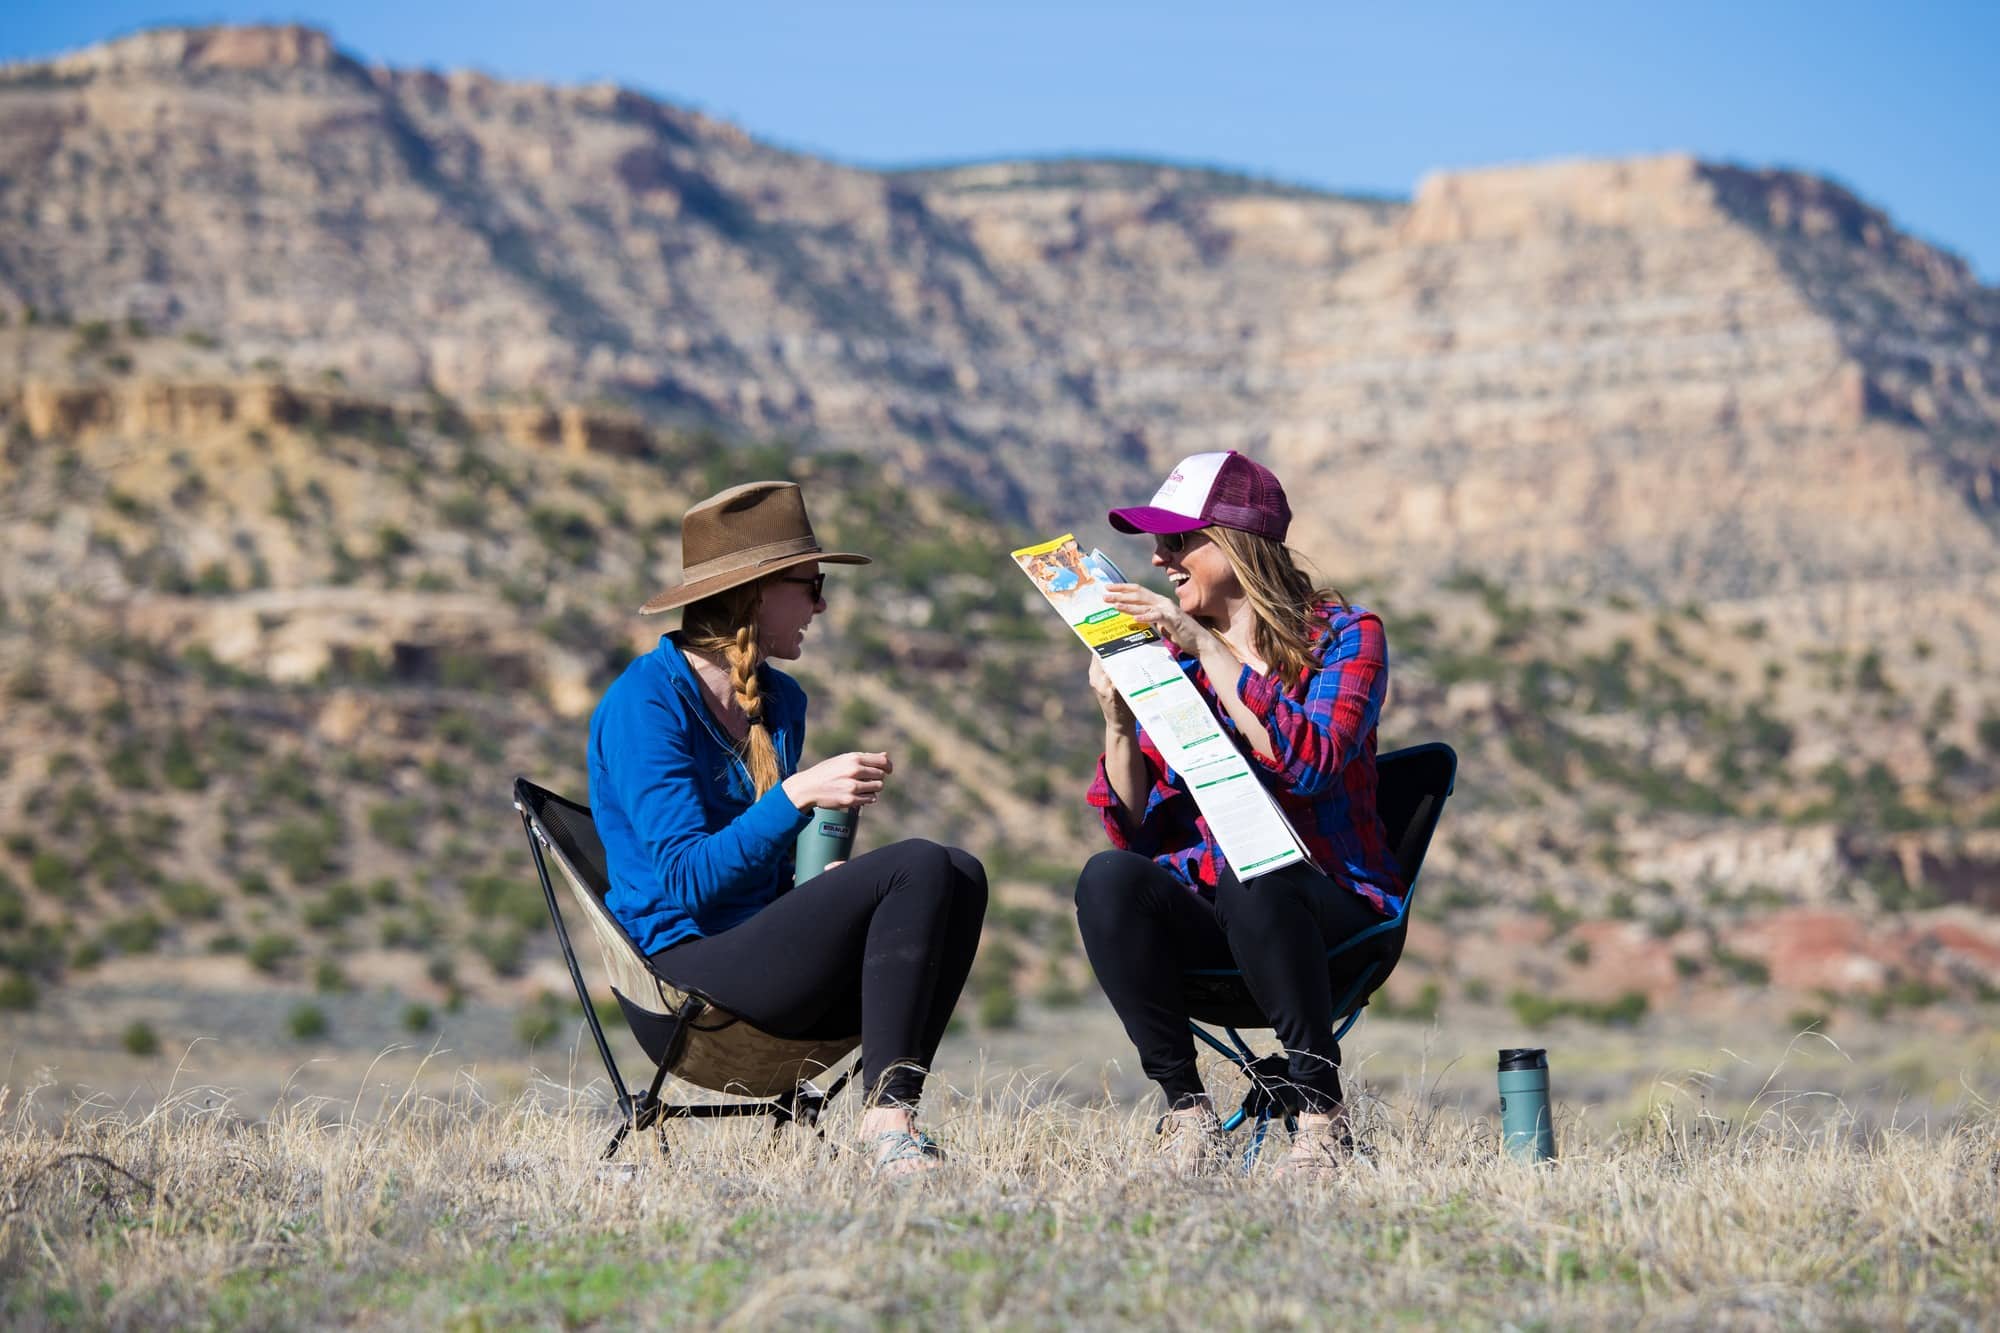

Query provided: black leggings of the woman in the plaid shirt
[1076,851,1392,1111]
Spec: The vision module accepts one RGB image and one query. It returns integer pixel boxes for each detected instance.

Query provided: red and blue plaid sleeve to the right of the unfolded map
[1236,610,1388,797]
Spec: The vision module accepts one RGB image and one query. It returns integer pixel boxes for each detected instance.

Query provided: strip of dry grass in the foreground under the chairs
[0,1040,2000,1327]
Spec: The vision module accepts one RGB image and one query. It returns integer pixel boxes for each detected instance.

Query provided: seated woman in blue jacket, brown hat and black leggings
[590,482,986,1175]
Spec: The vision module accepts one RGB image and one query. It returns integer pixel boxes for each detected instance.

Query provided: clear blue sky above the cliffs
[15,0,2000,282]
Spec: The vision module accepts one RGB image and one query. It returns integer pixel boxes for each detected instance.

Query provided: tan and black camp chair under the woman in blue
[514,779,860,1159]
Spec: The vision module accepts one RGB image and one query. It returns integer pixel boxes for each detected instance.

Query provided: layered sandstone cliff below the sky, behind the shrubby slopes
[0,28,2000,596]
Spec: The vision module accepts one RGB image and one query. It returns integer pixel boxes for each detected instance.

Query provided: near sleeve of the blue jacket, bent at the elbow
[604,684,806,921]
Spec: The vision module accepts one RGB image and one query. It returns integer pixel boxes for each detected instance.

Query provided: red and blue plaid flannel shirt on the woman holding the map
[1086,604,1404,917]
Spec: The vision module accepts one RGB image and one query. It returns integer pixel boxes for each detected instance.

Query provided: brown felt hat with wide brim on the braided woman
[638,482,870,616]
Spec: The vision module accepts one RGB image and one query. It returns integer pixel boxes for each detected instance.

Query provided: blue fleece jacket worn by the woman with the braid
[590,632,808,953]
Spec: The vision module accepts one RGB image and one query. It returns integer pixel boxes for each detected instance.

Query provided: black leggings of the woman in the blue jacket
[652,839,986,1107]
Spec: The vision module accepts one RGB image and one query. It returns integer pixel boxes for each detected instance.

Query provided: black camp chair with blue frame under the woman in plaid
[1182,741,1458,1169]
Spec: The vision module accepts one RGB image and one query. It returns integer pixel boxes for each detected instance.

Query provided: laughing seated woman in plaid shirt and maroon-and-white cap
[1076,450,1404,1177]
